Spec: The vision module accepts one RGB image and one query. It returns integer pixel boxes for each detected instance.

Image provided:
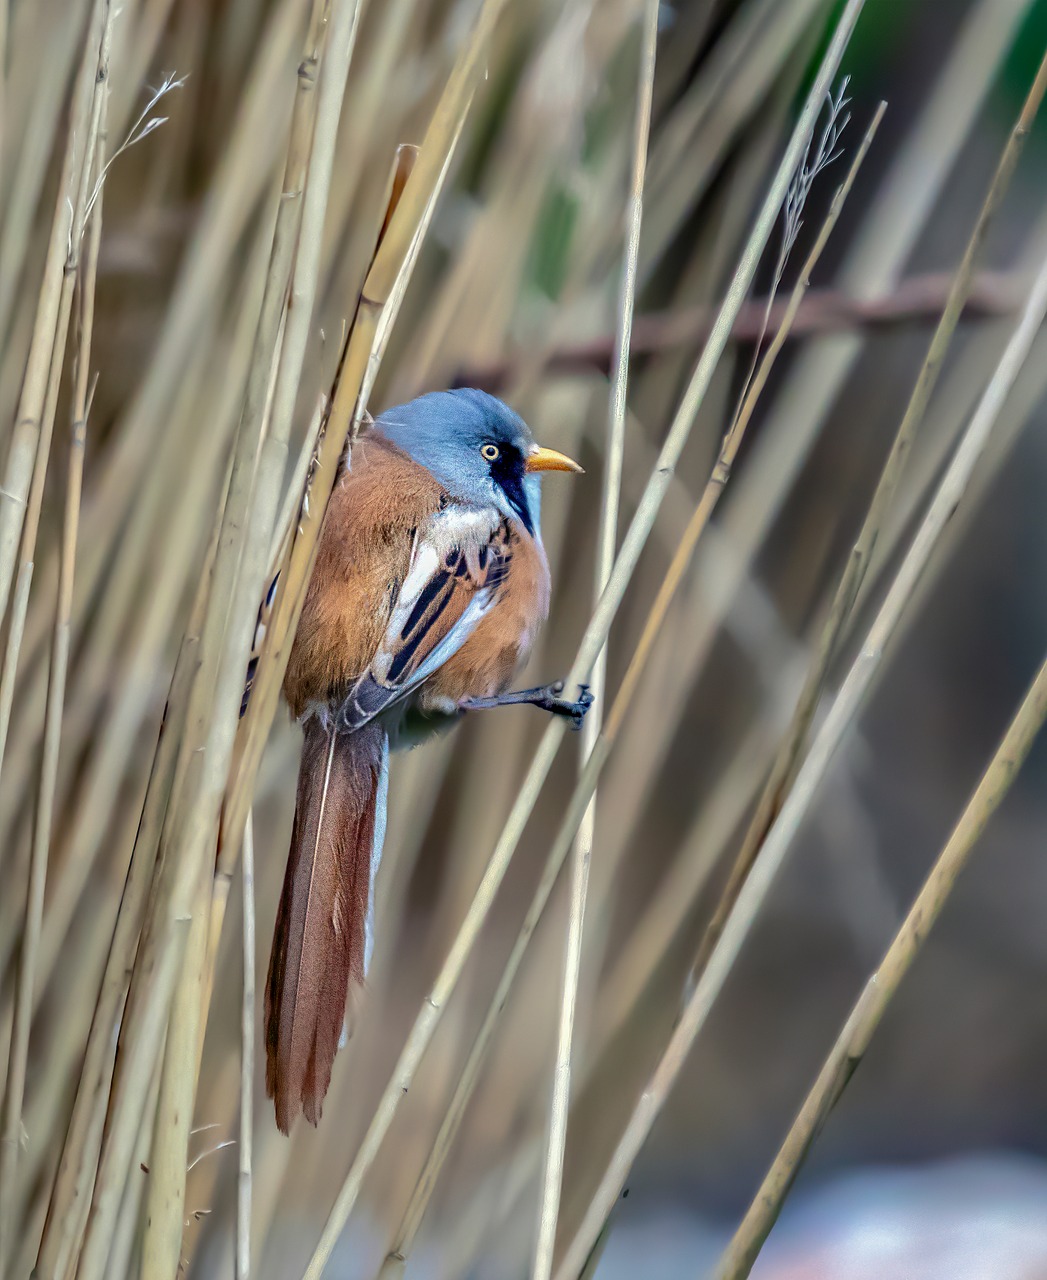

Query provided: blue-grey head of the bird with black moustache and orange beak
[374,387,581,536]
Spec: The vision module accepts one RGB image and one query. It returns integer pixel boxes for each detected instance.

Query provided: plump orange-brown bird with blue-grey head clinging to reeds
[261,388,593,1134]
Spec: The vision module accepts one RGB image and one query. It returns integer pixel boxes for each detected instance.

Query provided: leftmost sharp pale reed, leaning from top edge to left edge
[0,0,114,629]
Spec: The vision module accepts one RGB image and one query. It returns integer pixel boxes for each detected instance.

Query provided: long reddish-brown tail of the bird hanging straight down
[265,717,388,1133]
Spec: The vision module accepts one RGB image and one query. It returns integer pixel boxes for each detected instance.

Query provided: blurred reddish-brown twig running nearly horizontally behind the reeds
[453,271,1029,392]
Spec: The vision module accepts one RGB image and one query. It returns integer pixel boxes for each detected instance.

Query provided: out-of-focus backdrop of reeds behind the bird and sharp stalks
[0,0,1047,1280]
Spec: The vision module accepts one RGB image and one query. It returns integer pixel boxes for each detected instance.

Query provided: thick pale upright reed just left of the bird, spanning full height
[132,0,345,1259]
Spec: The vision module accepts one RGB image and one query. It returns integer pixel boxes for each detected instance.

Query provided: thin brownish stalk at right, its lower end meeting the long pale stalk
[691,47,1047,982]
